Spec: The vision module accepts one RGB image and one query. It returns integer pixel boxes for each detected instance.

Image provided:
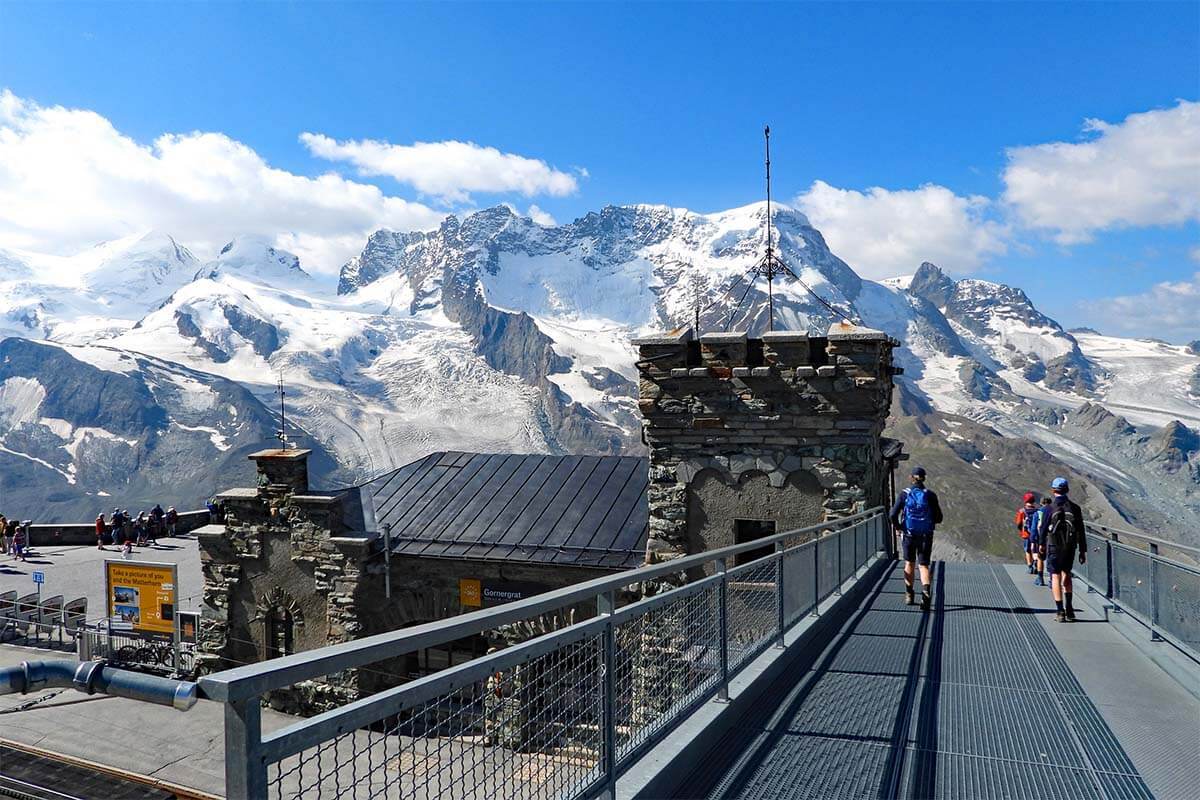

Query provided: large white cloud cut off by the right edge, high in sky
[1003,101,1200,245]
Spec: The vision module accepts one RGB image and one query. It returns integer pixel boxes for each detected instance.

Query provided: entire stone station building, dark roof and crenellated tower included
[198,326,898,711]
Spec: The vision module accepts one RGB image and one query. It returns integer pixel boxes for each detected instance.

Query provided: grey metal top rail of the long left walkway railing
[199,506,883,700]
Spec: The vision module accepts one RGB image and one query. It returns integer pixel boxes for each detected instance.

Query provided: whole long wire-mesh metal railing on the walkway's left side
[200,509,888,800]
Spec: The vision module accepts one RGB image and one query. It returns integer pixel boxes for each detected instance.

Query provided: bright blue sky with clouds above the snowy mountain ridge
[0,2,1200,339]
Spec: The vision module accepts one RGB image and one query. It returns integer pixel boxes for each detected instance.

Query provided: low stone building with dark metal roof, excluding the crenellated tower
[197,450,647,710]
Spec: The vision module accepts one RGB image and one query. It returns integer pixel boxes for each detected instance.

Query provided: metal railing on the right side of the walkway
[1076,524,1200,662]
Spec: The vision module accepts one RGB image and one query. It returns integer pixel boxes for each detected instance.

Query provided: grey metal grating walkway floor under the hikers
[672,563,1153,800]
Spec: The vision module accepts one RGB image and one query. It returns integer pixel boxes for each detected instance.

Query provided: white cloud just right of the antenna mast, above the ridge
[796,181,1007,278]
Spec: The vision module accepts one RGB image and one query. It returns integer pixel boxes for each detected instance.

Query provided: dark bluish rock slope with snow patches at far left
[0,338,337,522]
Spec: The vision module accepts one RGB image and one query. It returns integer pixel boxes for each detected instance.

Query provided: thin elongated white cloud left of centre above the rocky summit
[300,133,578,203]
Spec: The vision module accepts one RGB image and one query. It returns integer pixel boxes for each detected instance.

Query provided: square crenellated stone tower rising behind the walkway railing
[634,325,899,560]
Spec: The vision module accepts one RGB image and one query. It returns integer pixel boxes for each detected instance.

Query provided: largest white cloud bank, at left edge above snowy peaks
[0,91,444,272]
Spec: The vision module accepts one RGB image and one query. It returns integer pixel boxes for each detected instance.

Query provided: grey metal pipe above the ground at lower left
[0,661,199,711]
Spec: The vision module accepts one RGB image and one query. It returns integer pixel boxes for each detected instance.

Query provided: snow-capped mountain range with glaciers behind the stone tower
[0,204,1200,546]
